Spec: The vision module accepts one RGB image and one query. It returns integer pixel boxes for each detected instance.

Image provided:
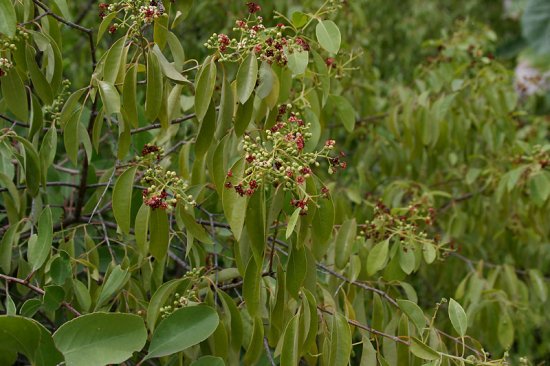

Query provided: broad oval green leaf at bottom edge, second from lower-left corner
[53,313,147,366]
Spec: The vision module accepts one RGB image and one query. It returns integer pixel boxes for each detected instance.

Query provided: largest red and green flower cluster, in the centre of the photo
[225,105,346,214]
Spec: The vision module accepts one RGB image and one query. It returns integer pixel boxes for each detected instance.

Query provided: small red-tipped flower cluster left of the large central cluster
[136,144,196,211]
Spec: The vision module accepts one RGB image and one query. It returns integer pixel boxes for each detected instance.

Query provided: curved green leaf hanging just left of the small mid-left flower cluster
[113,166,137,234]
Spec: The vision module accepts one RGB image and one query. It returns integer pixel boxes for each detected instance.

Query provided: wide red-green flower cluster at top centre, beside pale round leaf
[204,2,309,65]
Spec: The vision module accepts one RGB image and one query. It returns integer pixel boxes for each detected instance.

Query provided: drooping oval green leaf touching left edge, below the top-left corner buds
[0,68,29,122]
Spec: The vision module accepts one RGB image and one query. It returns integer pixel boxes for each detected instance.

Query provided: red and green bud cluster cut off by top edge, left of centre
[99,0,165,35]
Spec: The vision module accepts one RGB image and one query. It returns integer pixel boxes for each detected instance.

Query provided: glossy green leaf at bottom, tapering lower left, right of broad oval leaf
[144,305,220,360]
